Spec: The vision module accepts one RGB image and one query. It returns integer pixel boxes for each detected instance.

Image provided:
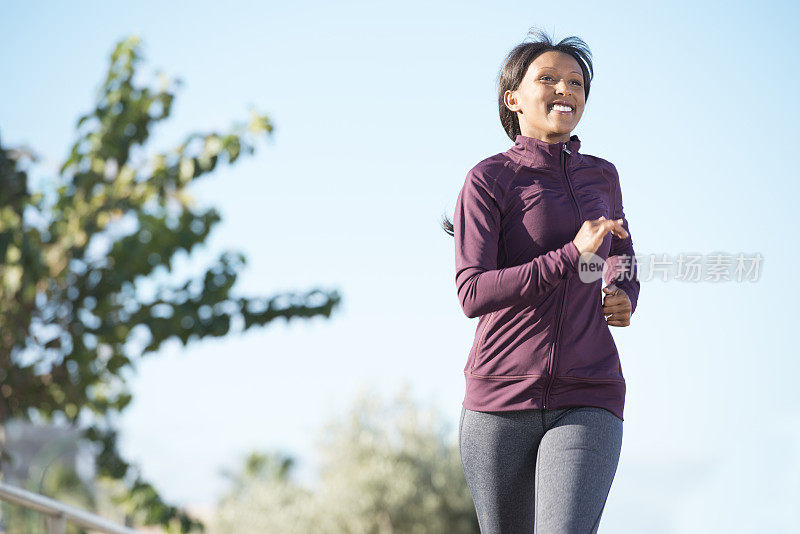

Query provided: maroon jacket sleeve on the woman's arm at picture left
[453,169,580,318]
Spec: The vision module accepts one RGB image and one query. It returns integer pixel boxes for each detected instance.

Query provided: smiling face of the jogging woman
[503,50,586,143]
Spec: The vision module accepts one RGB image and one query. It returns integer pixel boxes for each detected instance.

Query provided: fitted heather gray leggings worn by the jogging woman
[458,406,622,534]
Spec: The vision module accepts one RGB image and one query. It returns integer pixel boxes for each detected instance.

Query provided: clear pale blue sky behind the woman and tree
[0,1,800,532]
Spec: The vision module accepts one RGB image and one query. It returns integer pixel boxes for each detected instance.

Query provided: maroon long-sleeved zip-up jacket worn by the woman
[453,135,639,419]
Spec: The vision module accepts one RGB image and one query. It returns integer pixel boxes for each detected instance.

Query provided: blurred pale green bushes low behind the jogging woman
[210,389,479,534]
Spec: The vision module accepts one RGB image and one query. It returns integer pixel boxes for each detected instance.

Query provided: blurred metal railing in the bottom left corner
[0,482,139,534]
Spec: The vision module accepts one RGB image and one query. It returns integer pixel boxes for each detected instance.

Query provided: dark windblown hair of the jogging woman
[442,28,594,236]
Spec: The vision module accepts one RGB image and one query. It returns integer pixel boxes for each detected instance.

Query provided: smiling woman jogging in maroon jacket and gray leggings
[444,31,639,534]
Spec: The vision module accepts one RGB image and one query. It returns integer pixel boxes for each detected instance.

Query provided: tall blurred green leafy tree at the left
[0,36,340,532]
